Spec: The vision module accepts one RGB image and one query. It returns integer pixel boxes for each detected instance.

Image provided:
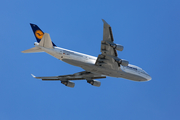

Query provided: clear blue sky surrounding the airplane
[0,0,180,120]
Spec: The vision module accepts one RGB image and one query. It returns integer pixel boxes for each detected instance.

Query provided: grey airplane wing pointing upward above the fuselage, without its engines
[95,20,120,69]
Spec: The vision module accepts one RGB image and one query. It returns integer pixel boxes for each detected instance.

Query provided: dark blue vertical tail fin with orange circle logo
[30,23,56,46]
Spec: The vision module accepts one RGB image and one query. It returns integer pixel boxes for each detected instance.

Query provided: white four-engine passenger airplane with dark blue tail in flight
[22,19,152,88]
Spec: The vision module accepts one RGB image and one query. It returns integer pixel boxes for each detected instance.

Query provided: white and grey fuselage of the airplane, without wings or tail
[35,43,151,81]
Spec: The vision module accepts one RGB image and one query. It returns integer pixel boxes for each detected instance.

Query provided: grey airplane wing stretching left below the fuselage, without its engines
[31,71,106,81]
